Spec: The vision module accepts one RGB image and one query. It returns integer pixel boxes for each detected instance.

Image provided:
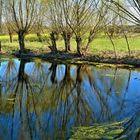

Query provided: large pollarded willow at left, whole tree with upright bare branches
[4,0,40,52]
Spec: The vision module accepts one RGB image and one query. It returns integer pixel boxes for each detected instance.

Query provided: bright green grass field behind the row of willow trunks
[0,34,140,53]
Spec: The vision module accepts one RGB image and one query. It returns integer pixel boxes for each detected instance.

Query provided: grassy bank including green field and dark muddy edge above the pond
[0,35,140,67]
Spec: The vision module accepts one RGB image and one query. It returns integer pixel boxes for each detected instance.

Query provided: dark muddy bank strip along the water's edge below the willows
[1,51,140,67]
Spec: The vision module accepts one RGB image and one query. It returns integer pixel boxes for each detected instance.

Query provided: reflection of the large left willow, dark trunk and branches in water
[1,60,41,139]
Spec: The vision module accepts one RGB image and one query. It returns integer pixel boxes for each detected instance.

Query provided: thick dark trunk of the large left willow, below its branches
[18,31,25,52]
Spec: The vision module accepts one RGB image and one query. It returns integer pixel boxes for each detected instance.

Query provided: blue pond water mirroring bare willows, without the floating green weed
[0,58,140,140]
